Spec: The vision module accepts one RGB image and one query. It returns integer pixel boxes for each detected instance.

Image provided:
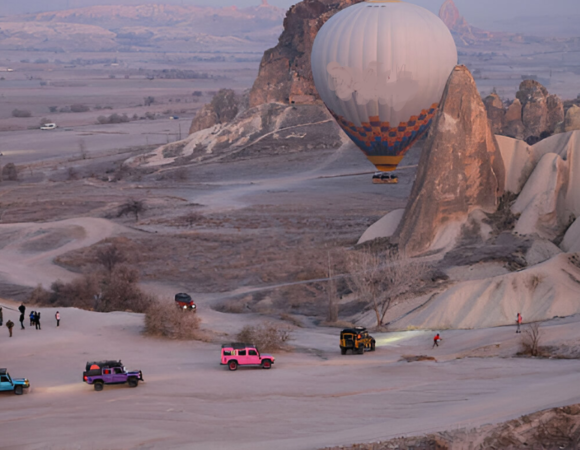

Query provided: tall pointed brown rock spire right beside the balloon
[396,66,505,255]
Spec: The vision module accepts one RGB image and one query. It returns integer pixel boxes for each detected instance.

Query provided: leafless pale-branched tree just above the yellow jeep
[347,250,426,326]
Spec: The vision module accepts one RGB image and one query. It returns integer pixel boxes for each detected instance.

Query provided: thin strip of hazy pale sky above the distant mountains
[0,0,580,26]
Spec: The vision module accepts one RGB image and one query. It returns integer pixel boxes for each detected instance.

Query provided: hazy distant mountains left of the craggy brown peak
[0,4,285,51]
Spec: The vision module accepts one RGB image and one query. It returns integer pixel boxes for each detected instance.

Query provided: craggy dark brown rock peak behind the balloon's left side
[250,0,363,107]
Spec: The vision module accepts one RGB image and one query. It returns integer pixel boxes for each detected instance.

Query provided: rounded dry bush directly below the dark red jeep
[145,300,200,340]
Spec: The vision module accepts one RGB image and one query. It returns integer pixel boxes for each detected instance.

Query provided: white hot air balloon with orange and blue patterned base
[311,0,457,172]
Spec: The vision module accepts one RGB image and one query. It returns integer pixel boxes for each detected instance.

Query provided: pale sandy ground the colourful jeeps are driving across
[0,302,580,450]
